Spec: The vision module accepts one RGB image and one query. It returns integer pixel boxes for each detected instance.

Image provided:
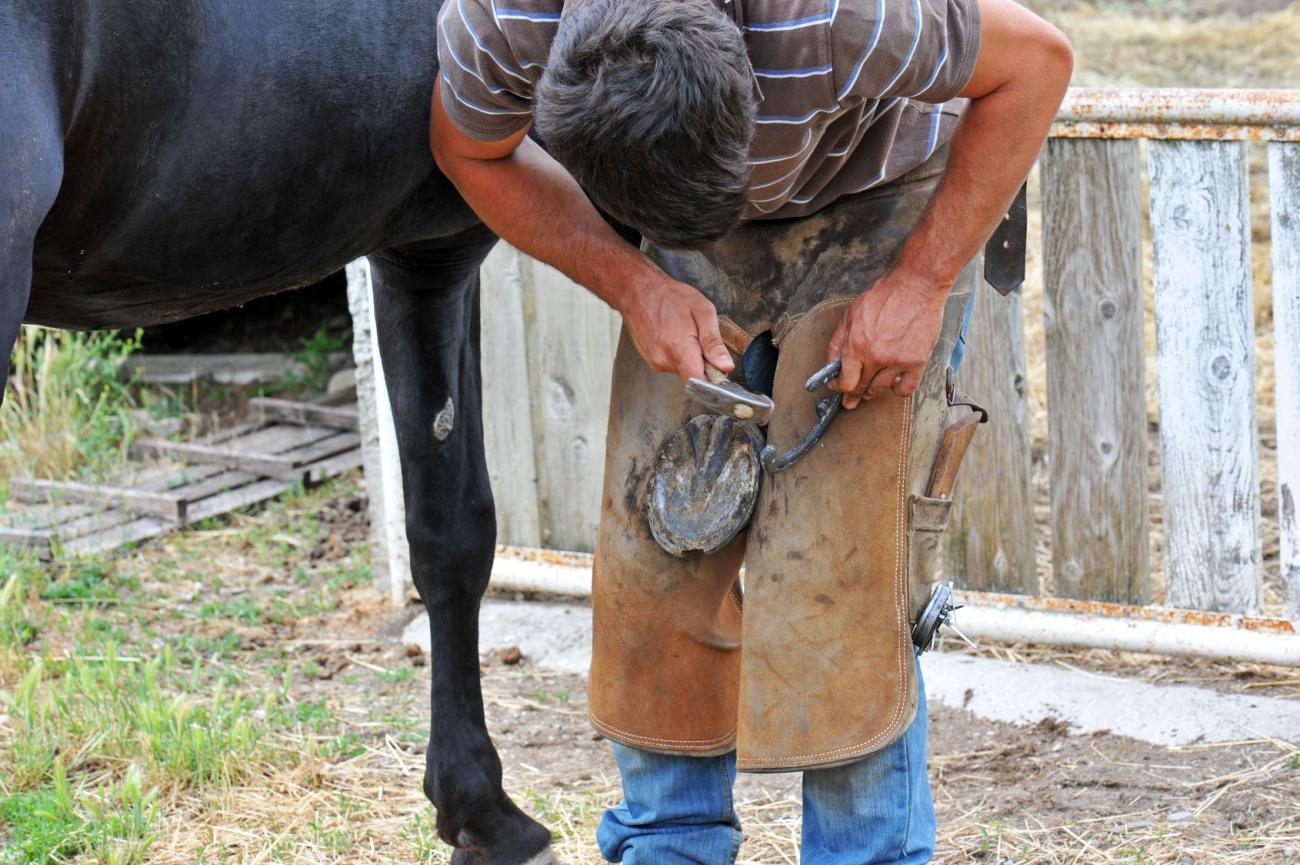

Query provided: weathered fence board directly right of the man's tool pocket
[946,280,1039,594]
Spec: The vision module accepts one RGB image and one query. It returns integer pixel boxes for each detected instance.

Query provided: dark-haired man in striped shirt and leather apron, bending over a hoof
[432,0,1071,865]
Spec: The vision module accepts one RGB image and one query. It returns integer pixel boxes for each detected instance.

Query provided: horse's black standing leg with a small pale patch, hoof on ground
[371,226,550,865]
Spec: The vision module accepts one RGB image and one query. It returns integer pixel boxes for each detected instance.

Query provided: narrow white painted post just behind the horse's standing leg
[347,259,411,605]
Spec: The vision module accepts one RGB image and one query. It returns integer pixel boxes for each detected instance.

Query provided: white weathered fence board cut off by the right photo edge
[1269,143,1300,622]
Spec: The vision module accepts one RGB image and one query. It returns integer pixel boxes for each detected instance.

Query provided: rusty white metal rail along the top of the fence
[1052,87,1300,142]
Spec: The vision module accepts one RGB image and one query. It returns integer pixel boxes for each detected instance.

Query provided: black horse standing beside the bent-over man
[0,0,564,865]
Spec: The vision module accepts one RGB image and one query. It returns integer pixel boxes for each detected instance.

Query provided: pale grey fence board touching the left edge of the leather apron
[521,251,619,550]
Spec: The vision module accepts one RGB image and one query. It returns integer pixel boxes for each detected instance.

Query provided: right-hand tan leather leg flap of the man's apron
[736,298,917,771]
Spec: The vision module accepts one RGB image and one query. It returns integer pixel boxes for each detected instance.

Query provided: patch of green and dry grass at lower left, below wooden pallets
[0,468,384,865]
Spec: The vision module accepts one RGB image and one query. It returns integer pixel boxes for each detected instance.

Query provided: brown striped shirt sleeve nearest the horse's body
[438,0,533,142]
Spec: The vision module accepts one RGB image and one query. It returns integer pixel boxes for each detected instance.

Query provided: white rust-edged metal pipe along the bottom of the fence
[491,548,1300,667]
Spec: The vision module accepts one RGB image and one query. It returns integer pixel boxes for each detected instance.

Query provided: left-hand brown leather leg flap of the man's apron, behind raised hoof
[589,333,745,756]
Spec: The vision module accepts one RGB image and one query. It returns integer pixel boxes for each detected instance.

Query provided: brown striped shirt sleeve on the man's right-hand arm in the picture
[831,0,980,103]
